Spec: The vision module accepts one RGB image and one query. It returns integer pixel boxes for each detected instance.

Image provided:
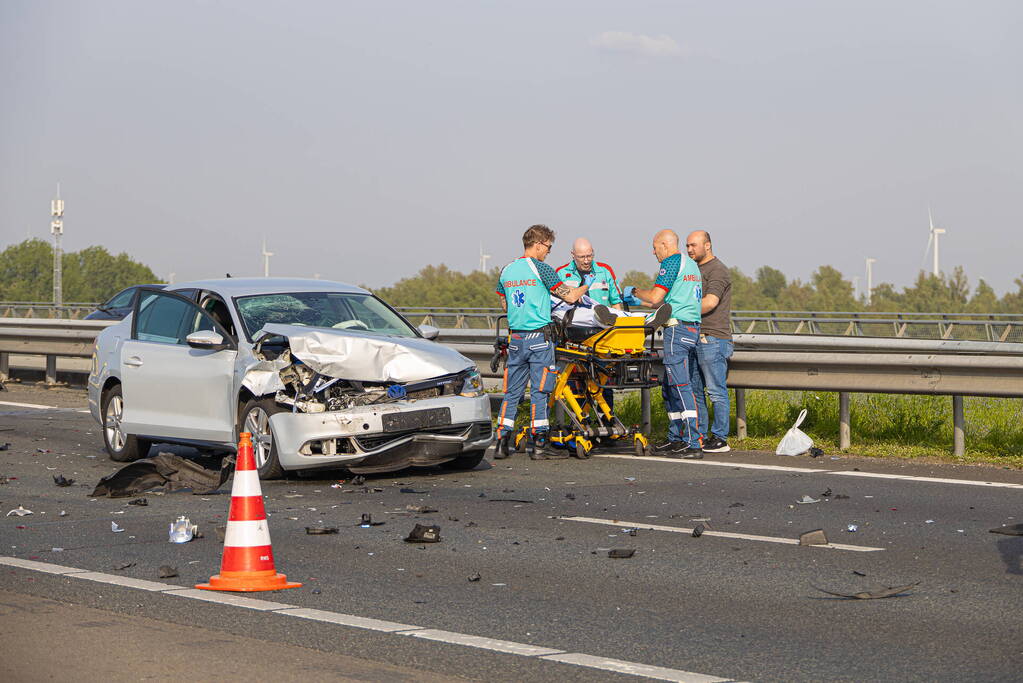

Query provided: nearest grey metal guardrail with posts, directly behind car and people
[0,319,1023,454]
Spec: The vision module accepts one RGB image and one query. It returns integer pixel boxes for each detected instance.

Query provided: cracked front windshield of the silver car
[237,291,416,337]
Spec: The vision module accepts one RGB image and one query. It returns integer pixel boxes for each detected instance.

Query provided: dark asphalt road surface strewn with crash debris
[0,385,1023,681]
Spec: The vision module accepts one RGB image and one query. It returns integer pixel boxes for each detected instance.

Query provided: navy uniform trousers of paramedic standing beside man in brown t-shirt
[661,323,701,448]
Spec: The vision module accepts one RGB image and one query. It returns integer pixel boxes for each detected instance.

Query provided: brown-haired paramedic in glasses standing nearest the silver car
[494,225,589,460]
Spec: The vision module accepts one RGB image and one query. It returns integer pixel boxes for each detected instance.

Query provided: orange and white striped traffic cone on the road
[195,431,302,592]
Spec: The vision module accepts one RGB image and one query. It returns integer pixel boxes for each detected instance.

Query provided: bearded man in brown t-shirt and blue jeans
[685,230,732,453]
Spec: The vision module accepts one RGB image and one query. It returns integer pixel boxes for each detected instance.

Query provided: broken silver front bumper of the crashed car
[270,396,493,472]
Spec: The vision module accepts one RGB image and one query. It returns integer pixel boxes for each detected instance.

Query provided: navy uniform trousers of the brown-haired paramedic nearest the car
[497,332,558,439]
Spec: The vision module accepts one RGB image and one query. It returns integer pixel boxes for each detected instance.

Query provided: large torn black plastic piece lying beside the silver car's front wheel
[89,453,234,498]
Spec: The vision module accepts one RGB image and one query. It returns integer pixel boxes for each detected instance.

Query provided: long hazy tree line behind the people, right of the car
[367,265,1023,314]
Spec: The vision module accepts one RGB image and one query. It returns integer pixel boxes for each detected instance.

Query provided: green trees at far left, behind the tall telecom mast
[0,238,163,303]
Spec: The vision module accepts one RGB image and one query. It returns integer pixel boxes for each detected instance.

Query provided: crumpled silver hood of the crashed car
[255,324,473,383]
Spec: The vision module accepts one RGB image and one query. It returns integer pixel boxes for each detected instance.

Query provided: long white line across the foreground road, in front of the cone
[0,555,736,683]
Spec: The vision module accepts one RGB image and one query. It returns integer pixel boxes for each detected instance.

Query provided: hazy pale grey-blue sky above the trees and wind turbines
[0,0,1023,292]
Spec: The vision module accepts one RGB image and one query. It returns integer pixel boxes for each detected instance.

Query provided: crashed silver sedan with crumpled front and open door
[89,278,493,479]
